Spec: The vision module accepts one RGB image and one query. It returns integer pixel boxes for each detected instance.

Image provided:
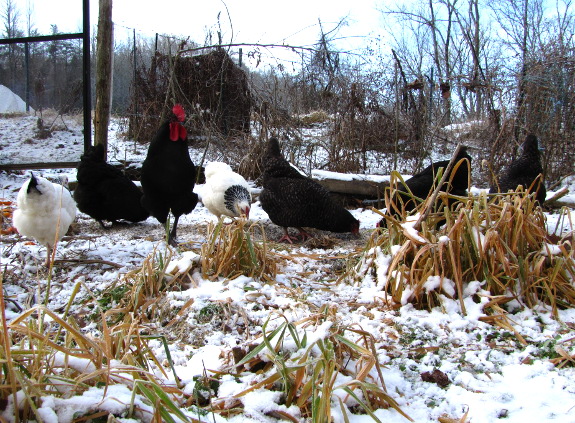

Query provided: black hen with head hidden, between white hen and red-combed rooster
[74,144,149,227]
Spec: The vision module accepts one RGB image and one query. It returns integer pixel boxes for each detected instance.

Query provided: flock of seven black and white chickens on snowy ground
[13,105,546,265]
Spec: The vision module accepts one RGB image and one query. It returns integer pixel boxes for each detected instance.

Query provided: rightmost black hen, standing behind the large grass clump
[489,134,547,204]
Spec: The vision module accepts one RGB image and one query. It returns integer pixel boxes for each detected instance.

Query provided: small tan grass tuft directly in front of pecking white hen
[201,219,278,281]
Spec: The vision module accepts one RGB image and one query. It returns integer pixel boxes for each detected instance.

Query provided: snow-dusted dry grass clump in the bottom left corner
[0,275,192,422]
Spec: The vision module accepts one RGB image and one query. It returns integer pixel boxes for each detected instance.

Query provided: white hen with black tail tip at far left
[13,174,76,266]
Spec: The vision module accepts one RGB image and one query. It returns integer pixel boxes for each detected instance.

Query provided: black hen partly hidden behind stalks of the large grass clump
[378,147,471,226]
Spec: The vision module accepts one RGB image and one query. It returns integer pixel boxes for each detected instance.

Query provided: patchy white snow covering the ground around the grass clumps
[0,116,575,423]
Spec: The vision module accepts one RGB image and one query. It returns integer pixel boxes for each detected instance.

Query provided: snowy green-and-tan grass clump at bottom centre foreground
[212,305,413,422]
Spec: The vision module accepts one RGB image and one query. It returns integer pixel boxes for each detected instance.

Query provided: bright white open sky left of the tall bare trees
[9,0,382,66]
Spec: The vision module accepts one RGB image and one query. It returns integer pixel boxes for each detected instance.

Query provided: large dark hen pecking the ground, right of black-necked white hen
[260,138,359,243]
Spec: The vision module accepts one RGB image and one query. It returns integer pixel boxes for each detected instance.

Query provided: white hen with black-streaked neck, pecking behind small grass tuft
[201,162,252,218]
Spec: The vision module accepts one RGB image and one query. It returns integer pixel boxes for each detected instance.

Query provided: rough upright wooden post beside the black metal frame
[94,0,113,157]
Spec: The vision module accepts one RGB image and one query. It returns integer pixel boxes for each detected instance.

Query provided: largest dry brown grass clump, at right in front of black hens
[351,192,575,313]
